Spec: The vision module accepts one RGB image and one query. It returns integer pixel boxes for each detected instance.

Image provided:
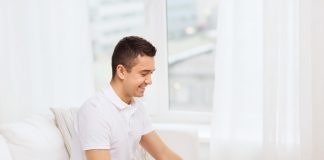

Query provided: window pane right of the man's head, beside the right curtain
[167,0,217,111]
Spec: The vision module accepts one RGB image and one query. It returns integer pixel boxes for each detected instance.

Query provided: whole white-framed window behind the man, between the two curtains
[89,0,216,122]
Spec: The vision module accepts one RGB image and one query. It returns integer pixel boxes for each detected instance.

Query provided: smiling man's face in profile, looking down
[123,55,155,98]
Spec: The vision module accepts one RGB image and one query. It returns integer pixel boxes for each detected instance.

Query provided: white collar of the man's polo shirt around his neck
[102,84,137,110]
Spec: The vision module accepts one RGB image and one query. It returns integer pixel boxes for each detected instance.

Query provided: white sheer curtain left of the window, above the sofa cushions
[0,0,93,122]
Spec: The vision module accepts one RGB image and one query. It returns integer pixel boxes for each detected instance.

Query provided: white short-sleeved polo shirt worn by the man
[71,85,153,160]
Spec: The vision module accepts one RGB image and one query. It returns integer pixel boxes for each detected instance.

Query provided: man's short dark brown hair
[111,36,156,77]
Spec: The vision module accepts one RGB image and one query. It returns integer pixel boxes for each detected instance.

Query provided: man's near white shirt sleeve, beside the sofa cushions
[77,104,112,150]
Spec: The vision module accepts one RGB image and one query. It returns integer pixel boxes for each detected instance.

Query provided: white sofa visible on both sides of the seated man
[0,109,198,160]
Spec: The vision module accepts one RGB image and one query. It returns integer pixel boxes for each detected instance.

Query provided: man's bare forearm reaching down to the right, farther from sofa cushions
[140,131,181,160]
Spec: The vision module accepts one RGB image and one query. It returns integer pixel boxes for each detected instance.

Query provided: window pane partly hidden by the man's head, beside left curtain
[89,0,145,89]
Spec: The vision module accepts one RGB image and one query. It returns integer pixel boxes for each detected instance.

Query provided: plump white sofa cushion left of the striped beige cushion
[0,115,69,160]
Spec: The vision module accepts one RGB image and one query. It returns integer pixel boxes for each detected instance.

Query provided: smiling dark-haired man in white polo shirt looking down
[71,36,181,160]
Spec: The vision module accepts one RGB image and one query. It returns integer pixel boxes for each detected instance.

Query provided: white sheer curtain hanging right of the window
[211,0,324,160]
